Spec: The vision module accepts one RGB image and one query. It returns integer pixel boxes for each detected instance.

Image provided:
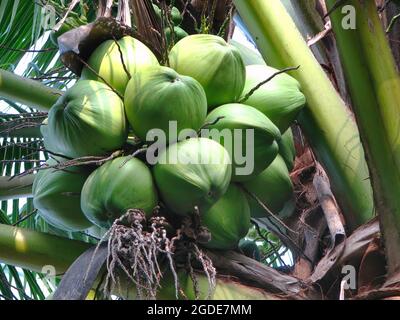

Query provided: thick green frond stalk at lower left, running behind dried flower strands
[0,224,288,300]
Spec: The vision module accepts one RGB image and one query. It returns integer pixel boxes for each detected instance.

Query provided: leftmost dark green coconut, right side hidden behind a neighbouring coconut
[32,160,92,231]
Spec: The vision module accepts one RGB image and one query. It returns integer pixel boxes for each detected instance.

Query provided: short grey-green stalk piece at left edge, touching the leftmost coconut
[0,174,34,201]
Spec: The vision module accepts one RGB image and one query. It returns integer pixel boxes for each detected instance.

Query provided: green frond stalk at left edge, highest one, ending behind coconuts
[0,69,62,111]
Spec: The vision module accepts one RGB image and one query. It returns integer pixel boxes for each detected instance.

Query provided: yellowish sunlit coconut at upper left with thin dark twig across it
[81,36,159,96]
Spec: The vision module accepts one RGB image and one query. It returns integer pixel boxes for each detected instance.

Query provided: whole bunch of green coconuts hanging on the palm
[33,33,305,255]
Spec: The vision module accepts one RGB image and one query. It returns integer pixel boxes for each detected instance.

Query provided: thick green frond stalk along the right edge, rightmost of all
[327,0,400,275]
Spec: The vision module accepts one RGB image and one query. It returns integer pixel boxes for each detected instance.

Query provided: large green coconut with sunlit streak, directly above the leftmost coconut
[41,80,128,158]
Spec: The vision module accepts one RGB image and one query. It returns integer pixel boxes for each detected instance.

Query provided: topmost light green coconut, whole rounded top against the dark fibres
[169,34,246,107]
